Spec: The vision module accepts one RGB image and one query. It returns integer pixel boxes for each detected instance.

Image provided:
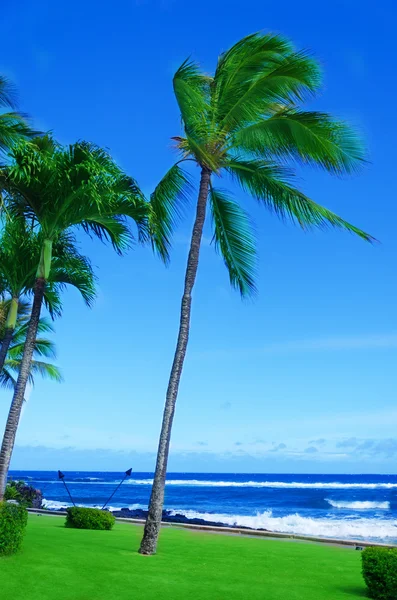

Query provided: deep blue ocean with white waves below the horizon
[10,471,397,544]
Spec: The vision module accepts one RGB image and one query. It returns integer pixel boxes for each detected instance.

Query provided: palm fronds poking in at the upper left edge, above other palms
[0,75,32,153]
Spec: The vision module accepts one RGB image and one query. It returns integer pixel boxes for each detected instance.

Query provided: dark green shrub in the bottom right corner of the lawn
[362,547,397,600]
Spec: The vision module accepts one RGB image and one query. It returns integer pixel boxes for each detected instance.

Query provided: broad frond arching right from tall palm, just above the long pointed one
[232,109,365,174]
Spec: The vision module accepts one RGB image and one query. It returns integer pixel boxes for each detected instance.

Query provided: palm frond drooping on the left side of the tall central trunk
[149,164,192,263]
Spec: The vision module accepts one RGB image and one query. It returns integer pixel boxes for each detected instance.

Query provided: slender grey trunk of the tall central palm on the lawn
[139,167,211,554]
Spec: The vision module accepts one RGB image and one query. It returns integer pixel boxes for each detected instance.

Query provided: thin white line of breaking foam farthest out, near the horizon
[125,479,397,490]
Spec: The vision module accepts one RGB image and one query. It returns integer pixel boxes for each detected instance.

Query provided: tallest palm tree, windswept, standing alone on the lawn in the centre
[140,33,371,554]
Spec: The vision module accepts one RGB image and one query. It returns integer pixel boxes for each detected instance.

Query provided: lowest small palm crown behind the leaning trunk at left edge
[0,300,62,389]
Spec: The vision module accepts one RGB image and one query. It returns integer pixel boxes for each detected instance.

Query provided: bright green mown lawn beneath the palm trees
[0,515,366,600]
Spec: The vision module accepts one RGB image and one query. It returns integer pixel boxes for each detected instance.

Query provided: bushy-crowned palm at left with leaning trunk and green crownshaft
[0,136,148,499]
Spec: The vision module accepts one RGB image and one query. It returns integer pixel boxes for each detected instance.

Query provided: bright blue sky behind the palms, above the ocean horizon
[0,0,397,473]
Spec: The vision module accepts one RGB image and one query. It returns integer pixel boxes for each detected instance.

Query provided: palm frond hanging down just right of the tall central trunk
[210,187,256,296]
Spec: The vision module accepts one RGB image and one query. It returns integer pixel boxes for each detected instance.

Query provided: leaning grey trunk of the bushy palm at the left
[0,278,45,500]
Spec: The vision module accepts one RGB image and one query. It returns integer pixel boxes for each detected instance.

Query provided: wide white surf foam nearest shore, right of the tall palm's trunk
[171,510,397,540]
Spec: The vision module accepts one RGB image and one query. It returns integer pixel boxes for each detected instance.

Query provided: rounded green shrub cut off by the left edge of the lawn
[0,502,28,555]
